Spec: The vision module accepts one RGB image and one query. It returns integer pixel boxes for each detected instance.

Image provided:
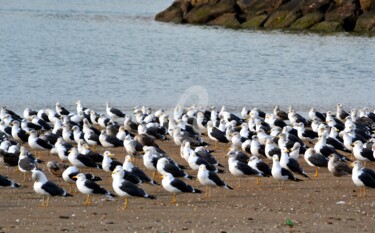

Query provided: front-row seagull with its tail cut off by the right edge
[352,160,375,196]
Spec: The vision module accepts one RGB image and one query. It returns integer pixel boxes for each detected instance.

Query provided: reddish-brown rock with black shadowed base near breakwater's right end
[325,0,361,31]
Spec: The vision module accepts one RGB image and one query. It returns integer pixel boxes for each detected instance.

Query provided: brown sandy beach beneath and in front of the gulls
[0,137,375,232]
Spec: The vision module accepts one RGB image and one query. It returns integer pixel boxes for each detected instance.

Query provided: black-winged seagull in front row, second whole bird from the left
[73,173,115,205]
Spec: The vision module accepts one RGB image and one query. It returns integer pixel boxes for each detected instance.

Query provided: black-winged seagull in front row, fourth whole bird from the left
[161,173,202,204]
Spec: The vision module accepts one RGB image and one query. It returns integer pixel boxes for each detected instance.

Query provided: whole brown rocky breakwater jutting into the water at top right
[155,0,375,34]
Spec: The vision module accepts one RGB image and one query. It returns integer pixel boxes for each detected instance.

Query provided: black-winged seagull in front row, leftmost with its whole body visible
[32,170,72,207]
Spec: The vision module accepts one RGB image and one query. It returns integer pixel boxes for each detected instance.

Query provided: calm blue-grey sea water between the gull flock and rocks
[0,0,375,112]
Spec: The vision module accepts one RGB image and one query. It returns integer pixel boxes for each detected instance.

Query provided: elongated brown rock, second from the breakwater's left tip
[184,0,236,24]
